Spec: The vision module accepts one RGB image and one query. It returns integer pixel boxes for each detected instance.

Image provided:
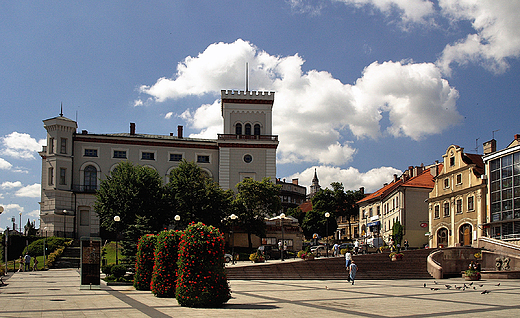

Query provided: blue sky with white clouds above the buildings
[0,0,520,230]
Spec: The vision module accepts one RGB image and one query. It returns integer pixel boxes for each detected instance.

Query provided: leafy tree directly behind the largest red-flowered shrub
[165,160,233,227]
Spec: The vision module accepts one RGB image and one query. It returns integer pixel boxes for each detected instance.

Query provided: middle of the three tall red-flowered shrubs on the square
[150,230,182,297]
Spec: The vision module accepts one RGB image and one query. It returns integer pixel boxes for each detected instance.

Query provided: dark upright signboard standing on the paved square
[80,237,101,289]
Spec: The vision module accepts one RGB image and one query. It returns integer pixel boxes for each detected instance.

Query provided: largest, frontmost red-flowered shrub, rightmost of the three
[176,222,231,308]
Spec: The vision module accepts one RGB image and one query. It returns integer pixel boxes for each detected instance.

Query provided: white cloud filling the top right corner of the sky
[437,0,520,74]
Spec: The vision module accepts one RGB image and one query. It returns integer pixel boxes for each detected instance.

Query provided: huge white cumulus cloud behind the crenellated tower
[136,39,461,165]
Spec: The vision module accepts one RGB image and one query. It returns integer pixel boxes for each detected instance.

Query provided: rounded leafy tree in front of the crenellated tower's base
[234,178,282,249]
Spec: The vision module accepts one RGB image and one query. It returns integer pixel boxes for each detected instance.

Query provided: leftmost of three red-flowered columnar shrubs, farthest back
[134,234,157,290]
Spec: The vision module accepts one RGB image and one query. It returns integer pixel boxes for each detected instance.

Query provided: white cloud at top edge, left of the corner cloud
[335,0,435,24]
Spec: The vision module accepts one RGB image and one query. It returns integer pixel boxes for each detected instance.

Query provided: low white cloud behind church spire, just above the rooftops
[288,166,402,192]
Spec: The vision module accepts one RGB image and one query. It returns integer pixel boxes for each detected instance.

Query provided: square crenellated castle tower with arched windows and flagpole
[218,90,278,189]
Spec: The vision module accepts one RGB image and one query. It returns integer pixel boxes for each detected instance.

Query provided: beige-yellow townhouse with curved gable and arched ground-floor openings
[428,145,486,247]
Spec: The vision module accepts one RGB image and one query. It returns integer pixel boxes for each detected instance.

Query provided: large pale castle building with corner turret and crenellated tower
[39,90,278,238]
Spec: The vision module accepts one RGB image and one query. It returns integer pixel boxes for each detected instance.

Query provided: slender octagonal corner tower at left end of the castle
[39,114,78,237]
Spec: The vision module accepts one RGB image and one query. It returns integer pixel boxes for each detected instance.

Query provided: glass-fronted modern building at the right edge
[482,134,520,240]
